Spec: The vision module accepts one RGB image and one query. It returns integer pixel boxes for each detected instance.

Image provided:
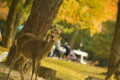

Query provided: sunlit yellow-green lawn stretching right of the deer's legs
[42,58,107,80]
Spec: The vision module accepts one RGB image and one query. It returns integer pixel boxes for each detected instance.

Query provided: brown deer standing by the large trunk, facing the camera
[7,28,62,80]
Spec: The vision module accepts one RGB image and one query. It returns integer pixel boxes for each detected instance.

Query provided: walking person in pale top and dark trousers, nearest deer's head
[52,37,61,59]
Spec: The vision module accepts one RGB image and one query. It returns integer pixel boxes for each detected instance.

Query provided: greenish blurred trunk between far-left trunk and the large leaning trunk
[12,0,33,42]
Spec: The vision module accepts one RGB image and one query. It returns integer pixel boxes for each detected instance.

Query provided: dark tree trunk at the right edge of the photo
[107,1,120,79]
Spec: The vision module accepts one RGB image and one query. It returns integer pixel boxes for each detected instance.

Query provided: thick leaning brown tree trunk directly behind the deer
[6,0,63,68]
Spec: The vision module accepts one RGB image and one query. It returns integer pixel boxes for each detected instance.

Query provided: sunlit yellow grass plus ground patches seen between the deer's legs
[0,58,107,80]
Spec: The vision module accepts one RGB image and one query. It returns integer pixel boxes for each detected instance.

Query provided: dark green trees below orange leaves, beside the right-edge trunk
[83,21,115,66]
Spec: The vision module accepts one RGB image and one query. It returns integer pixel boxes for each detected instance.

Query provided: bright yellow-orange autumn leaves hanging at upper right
[57,0,117,36]
